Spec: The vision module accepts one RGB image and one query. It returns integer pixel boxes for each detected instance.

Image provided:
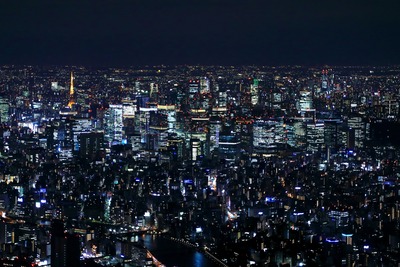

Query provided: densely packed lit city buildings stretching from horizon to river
[0,66,400,266]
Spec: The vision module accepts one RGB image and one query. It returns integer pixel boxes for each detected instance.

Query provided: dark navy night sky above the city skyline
[0,0,400,66]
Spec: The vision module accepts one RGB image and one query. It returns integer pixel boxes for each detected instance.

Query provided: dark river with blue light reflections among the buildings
[143,235,217,267]
